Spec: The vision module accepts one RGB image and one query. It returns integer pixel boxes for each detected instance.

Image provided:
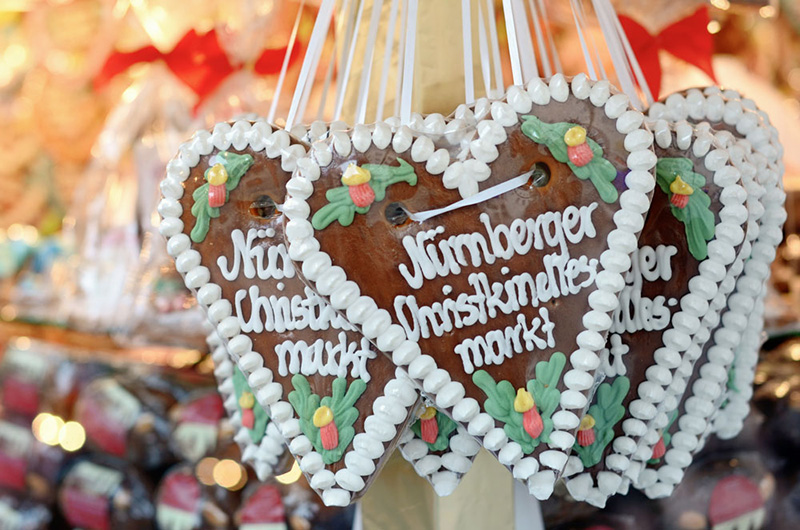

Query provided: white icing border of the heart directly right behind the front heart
[565,120,748,507]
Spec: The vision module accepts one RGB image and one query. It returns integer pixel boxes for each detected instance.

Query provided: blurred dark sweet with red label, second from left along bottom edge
[58,455,155,530]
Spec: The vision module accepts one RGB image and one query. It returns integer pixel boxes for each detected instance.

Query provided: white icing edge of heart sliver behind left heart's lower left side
[206,330,286,482]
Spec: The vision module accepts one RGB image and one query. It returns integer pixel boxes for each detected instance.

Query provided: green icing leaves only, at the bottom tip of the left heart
[289,374,367,464]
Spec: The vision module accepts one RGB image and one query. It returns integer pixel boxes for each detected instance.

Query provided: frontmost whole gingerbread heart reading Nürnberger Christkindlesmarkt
[284,75,655,498]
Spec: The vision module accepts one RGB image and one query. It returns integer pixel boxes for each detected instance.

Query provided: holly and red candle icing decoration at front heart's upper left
[311,158,417,230]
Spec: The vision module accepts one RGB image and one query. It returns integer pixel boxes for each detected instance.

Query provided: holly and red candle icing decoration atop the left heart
[190,151,253,243]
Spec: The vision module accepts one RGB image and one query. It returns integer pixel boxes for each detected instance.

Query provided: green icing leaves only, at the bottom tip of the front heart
[472,352,567,455]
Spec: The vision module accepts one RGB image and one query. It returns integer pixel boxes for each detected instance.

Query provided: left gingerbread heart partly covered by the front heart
[159,121,417,506]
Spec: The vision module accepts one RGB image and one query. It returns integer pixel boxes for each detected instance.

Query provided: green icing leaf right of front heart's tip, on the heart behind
[573,377,631,467]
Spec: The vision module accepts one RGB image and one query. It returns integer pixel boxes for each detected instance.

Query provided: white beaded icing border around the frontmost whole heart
[283,74,656,499]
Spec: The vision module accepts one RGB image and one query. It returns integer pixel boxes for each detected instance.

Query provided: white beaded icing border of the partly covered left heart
[158,120,417,506]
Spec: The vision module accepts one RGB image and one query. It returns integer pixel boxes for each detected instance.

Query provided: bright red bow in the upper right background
[619,6,717,99]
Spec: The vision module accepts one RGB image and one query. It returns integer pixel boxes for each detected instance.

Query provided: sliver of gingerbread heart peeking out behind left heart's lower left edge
[207,330,292,481]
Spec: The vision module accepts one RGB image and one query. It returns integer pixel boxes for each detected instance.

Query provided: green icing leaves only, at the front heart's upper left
[311,158,417,230]
